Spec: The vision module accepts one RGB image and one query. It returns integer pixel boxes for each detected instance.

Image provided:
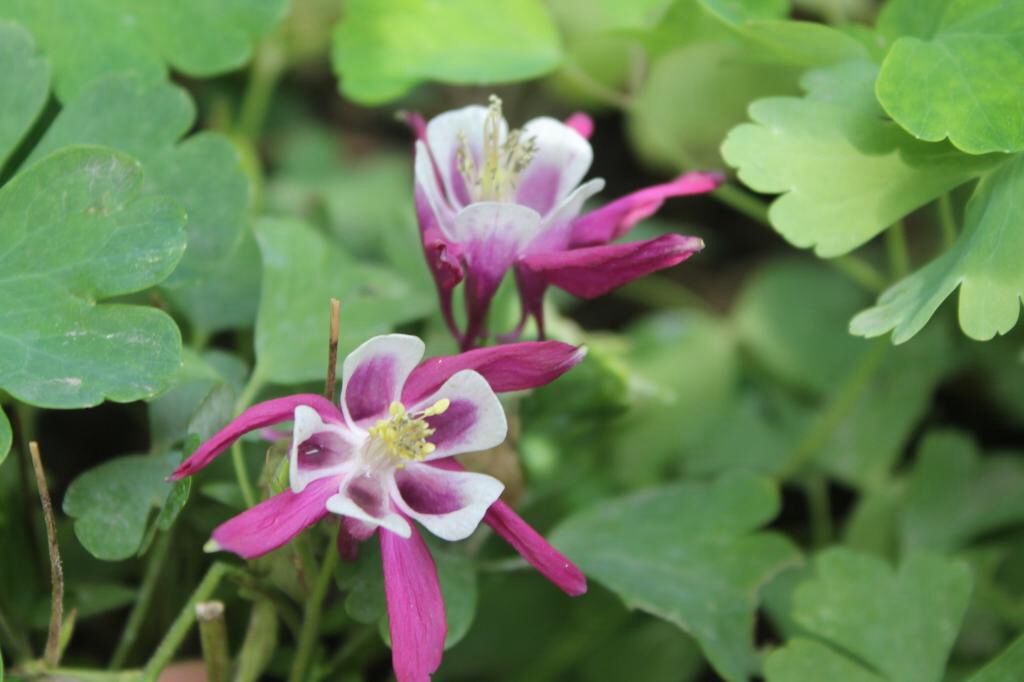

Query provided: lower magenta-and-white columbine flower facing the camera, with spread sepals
[172,334,587,682]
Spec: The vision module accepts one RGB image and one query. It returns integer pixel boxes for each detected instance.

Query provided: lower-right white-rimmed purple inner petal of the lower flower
[391,462,505,542]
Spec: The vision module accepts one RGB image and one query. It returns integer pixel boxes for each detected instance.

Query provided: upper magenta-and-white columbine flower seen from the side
[409,96,722,348]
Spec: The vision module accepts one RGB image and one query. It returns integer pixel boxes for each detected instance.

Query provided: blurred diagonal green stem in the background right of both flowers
[779,339,889,479]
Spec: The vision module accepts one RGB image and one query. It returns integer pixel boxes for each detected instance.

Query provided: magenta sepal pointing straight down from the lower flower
[380,528,447,682]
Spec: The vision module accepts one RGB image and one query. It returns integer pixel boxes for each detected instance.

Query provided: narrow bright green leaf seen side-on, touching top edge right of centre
[699,0,867,67]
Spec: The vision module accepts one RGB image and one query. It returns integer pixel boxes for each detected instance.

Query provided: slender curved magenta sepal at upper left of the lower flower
[170,393,345,480]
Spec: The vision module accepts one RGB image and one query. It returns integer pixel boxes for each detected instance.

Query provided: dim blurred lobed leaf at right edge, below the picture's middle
[901,431,1024,552]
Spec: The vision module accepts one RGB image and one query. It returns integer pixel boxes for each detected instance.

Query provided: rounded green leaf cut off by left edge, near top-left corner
[0,22,50,166]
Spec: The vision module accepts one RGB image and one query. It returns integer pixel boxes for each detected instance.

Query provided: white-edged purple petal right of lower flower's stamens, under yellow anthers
[410,370,508,461]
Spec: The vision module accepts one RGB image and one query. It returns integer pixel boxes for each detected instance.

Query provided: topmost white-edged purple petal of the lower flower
[341,334,424,425]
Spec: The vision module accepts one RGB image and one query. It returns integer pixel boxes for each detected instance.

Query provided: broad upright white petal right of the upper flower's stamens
[515,117,594,215]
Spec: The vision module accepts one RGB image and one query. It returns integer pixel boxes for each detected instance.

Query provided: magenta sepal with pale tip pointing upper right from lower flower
[401,341,587,404]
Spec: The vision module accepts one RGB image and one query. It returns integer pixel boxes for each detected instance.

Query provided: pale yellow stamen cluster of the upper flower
[456,95,537,202]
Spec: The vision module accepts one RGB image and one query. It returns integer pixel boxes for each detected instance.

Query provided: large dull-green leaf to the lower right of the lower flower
[552,473,800,682]
